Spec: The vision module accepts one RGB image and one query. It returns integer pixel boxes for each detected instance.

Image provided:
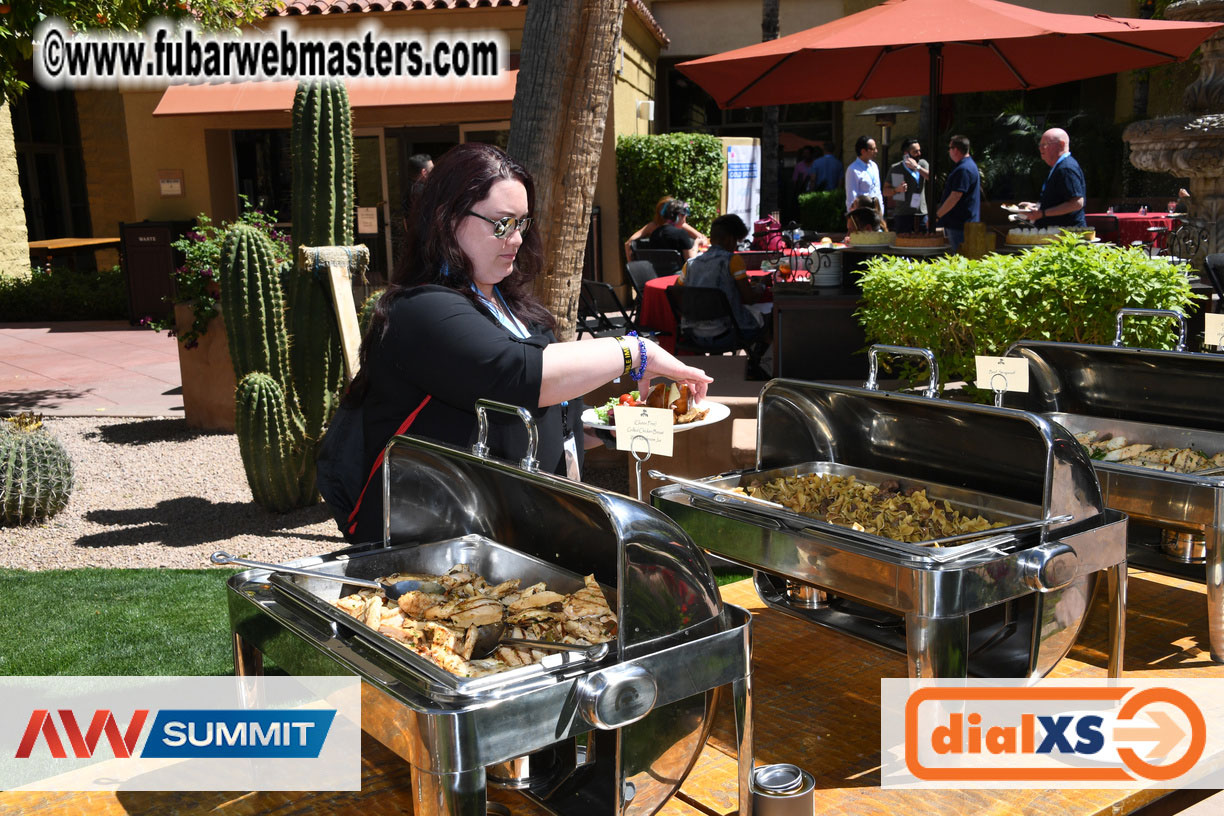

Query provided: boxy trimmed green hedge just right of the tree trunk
[616,133,719,242]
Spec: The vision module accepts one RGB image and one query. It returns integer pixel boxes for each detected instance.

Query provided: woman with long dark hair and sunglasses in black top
[345,143,712,541]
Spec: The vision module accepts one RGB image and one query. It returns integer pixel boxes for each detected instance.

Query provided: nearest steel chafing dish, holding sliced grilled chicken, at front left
[228,401,753,816]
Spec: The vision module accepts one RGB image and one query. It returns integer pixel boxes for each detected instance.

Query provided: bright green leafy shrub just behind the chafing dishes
[857,235,1193,382]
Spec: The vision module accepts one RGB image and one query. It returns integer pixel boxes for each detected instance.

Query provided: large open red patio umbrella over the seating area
[676,0,1220,201]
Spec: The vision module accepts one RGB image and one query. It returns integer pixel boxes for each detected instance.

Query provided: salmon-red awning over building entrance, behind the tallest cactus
[153,71,519,116]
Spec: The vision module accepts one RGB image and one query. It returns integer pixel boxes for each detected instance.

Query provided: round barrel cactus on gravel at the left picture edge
[0,414,72,526]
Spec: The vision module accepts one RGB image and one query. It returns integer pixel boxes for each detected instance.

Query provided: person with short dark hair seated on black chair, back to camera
[676,214,772,364]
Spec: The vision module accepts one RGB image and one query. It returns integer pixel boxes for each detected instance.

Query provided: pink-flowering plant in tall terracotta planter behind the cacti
[142,204,291,431]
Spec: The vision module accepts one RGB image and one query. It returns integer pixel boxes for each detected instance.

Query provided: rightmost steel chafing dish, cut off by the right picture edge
[1007,310,1224,662]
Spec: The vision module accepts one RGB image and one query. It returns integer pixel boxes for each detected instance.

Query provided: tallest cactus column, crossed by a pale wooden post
[286,80,355,439]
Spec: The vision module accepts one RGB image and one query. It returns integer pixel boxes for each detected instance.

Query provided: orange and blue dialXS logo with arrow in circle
[905,684,1207,787]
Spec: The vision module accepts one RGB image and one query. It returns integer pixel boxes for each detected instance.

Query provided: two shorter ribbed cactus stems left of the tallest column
[220,224,316,513]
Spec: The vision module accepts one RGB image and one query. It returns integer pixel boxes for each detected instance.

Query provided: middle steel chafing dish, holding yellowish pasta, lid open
[652,367,1126,677]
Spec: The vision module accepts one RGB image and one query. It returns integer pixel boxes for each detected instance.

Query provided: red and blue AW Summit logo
[15,708,335,760]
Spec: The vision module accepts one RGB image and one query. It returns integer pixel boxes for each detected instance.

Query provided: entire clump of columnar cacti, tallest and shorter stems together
[220,81,354,513]
